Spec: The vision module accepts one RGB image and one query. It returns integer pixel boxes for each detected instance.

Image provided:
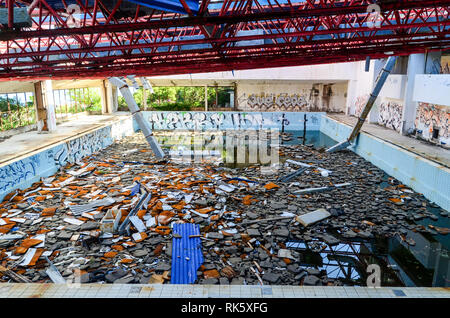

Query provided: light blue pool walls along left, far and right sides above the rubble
[0,112,450,211]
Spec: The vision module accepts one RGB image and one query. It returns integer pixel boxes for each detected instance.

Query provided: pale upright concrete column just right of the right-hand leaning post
[402,54,425,135]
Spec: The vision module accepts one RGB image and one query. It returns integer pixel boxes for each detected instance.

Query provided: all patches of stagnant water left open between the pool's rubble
[156,131,450,287]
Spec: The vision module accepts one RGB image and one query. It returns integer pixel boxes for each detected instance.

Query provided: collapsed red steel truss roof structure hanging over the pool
[0,0,450,81]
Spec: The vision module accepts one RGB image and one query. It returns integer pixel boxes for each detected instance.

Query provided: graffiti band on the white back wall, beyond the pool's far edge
[247,94,310,111]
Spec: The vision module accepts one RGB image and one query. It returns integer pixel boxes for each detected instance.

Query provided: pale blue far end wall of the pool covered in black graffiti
[148,112,321,130]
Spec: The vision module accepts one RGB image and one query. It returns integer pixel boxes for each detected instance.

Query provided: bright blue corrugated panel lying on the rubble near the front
[170,223,203,284]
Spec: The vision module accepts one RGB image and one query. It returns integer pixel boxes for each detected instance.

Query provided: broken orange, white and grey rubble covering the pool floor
[0,134,448,285]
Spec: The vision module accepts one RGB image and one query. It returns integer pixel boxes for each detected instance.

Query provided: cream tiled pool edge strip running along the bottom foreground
[0,283,450,298]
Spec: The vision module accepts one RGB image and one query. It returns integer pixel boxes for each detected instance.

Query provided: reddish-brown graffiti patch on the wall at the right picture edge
[414,103,450,145]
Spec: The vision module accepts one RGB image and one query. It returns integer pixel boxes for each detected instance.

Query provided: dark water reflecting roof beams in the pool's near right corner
[286,227,450,287]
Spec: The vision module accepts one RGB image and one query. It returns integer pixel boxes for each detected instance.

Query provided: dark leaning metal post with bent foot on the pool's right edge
[327,56,397,152]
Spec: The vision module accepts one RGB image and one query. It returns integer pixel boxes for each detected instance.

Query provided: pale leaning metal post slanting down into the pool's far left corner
[108,77,165,159]
